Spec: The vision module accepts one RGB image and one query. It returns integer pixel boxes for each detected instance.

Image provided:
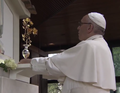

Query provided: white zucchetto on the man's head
[88,12,106,29]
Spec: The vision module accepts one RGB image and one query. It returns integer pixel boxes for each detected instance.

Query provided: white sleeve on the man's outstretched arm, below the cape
[31,57,64,77]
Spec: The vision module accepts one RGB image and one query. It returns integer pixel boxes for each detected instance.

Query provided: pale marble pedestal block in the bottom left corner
[0,76,38,93]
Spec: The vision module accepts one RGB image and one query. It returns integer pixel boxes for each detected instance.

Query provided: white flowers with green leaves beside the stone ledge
[0,59,17,72]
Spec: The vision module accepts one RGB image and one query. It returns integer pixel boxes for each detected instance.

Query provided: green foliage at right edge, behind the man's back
[112,47,120,76]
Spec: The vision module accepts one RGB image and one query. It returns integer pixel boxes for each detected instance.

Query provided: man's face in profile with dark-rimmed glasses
[77,15,90,41]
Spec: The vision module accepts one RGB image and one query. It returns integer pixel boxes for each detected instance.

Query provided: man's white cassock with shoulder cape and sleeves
[31,35,116,93]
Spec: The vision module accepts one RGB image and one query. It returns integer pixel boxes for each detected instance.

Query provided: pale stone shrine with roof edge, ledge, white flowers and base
[0,0,38,93]
